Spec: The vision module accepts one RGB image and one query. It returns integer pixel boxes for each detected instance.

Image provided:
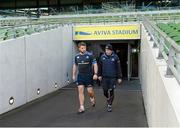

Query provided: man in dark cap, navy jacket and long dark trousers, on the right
[98,44,122,112]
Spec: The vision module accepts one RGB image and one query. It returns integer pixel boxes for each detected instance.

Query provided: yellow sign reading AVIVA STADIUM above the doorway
[73,25,140,40]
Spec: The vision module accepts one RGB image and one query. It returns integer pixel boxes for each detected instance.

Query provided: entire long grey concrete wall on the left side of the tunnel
[0,26,75,114]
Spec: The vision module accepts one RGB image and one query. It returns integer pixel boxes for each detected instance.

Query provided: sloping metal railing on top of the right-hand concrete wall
[143,17,180,83]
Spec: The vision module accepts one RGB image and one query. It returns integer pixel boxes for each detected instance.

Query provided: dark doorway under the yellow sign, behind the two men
[76,40,140,80]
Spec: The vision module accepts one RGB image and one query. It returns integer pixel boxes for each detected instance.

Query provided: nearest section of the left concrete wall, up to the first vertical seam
[0,37,26,113]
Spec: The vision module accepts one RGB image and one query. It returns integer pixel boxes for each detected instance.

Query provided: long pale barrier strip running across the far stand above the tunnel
[0,10,180,27]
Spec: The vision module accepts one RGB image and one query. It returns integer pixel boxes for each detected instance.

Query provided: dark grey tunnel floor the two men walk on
[0,80,148,127]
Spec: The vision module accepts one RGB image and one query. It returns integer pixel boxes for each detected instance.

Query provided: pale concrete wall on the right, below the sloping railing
[140,24,180,127]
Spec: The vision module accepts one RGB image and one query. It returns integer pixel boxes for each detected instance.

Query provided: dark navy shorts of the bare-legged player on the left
[76,74,93,87]
